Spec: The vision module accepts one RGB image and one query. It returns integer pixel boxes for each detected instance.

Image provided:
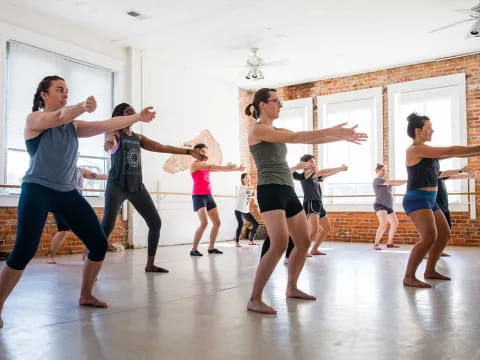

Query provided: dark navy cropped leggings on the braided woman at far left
[7,183,107,270]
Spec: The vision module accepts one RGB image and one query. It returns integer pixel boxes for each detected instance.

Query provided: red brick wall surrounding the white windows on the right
[239,55,480,246]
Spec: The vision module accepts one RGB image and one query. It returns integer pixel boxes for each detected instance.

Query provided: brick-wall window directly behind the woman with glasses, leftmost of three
[273,98,313,196]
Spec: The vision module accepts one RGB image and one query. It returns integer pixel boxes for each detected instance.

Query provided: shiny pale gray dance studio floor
[0,242,480,360]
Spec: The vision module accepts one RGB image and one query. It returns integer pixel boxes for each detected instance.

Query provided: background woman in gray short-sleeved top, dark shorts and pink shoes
[373,164,407,250]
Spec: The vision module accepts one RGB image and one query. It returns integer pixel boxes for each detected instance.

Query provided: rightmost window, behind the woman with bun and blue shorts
[388,74,467,203]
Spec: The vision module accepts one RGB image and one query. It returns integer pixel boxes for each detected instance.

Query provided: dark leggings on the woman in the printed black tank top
[102,182,162,256]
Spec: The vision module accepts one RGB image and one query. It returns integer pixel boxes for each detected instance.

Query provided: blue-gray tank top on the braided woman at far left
[23,123,78,191]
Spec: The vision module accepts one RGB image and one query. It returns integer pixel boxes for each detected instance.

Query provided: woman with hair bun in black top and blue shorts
[403,113,480,288]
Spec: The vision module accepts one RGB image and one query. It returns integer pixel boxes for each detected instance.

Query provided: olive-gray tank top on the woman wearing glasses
[250,141,293,187]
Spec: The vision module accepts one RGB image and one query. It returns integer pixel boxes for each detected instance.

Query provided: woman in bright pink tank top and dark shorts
[190,144,244,256]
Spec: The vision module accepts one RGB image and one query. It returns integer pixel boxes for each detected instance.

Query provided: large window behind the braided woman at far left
[4,41,113,195]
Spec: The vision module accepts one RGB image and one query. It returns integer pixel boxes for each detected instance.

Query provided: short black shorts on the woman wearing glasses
[257,184,303,217]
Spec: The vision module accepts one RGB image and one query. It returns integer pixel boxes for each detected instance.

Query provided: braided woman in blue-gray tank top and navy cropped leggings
[0,76,155,327]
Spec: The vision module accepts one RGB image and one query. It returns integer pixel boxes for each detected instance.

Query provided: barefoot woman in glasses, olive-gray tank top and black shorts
[245,89,367,314]
